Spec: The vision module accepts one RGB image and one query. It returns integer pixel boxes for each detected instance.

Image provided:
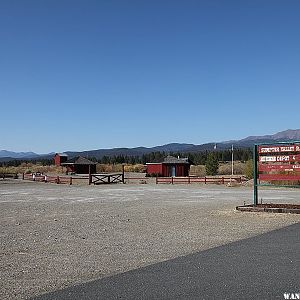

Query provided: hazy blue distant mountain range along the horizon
[0,129,300,161]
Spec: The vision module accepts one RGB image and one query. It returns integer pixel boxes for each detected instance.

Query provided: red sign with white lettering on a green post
[253,142,300,205]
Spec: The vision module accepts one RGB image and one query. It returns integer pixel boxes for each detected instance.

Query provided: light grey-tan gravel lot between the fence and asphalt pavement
[0,180,300,299]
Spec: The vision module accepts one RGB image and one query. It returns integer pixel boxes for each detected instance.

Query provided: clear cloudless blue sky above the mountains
[0,0,300,153]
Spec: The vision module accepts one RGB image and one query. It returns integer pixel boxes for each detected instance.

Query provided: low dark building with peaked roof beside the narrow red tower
[61,156,96,174]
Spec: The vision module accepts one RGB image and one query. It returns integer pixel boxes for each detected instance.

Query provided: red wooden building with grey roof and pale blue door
[146,156,191,177]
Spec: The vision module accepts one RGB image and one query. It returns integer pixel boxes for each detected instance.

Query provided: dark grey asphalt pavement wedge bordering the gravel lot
[34,223,300,300]
